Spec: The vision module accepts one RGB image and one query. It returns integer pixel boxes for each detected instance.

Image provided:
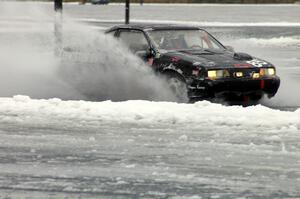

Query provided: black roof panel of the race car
[106,24,202,32]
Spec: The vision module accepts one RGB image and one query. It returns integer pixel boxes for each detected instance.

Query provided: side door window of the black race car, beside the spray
[119,30,149,53]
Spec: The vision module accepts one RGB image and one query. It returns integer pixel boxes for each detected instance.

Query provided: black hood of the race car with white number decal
[164,50,271,68]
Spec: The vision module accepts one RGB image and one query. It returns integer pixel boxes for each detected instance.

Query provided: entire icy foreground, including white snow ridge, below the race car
[0,96,300,199]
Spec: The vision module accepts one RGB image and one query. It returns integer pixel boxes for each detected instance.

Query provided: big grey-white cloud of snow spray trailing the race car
[0,2,177,101]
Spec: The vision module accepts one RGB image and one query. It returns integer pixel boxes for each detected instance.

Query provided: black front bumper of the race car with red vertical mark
[189,76,280,98]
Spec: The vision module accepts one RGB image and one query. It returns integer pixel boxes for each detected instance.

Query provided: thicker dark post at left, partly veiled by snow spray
[54,0,63,56]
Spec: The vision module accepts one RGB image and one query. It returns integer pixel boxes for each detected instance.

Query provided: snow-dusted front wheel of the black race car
[165,72,189,103]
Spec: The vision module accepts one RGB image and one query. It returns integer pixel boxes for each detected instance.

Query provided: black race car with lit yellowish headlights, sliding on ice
[106,25,280,103]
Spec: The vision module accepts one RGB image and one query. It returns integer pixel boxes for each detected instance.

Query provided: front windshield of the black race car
[148,30,224,50]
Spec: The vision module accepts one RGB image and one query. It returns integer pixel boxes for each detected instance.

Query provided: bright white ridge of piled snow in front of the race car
[0,96,300,132]
